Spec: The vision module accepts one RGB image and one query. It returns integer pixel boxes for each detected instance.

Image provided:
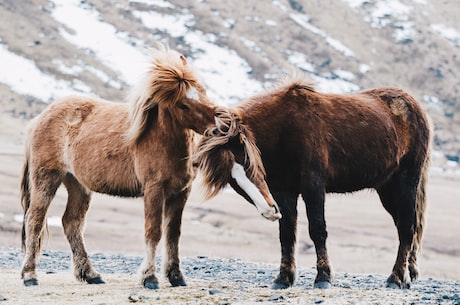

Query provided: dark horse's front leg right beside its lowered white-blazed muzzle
[272,193,297,289]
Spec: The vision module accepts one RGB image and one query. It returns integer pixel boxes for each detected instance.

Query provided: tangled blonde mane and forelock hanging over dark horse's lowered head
[193,108,265,199]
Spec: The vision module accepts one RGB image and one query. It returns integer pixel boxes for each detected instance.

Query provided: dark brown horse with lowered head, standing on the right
[195,75,431,288]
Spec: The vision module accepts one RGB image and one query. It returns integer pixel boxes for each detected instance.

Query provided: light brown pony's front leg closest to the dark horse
[163,189,190,287]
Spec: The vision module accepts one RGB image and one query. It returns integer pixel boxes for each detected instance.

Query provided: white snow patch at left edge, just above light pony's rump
[0,44,81,102]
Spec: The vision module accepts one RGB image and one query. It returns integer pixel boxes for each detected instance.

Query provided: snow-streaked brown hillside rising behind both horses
[0,0,460,171]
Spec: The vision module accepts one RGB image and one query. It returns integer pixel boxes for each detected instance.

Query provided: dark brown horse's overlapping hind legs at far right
[377,172,418,288]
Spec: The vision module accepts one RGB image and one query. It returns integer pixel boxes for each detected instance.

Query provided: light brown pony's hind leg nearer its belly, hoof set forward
[62,174,104,284]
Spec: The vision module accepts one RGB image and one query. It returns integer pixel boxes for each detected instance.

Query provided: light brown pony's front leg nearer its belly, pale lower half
[141,186,165,289]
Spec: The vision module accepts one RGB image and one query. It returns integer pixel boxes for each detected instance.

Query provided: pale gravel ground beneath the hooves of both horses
[0,248,460,305]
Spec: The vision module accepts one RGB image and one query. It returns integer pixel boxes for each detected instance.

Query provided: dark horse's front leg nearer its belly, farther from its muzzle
[302,187,332,289]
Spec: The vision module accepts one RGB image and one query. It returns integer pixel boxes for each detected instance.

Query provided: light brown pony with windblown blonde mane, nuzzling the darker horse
[21,45,221,289]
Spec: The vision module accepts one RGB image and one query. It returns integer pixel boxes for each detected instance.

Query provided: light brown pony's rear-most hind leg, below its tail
[21,169,61,286]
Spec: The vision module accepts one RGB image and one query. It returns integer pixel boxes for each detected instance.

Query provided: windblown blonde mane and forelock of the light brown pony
[126,43,200,145]
